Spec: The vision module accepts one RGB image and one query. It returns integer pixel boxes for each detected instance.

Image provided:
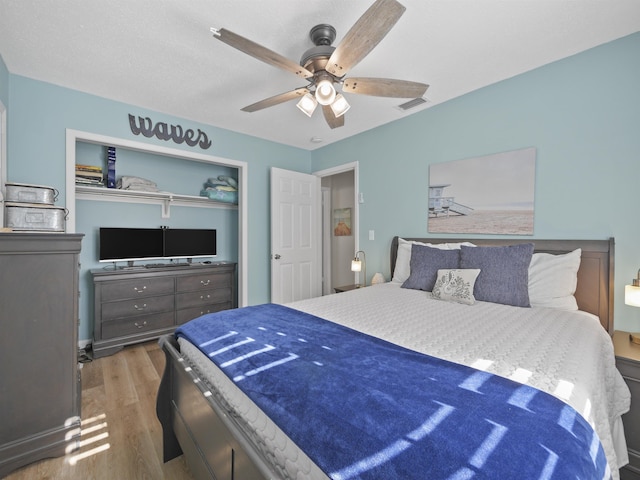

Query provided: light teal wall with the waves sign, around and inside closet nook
[0,72,311,340]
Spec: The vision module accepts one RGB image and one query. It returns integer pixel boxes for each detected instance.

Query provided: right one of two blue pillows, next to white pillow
[460,243,533,307]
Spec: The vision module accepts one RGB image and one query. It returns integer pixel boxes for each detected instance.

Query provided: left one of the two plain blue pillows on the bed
[402,245,460,292]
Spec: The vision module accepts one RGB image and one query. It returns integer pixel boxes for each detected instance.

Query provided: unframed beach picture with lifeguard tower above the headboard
[427,147,536,235]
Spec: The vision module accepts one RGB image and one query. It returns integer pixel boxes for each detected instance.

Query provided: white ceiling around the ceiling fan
[0,0,640,150]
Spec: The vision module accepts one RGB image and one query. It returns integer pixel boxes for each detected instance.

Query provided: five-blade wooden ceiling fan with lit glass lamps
[211,0,428,128]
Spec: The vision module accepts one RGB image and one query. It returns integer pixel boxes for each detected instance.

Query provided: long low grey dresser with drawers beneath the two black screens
[91,262,237,358]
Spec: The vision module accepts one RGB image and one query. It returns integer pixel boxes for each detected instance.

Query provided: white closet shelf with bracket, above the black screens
[76,185,238,218]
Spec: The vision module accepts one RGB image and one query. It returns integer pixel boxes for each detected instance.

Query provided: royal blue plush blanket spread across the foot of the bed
[176,304,609,480]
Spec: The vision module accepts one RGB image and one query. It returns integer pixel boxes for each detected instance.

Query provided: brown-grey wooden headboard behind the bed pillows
[391,237,614,333]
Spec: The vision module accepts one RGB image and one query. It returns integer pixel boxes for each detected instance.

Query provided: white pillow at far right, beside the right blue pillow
[529,248,582,310]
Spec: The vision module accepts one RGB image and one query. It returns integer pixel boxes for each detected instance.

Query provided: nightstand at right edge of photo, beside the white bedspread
[613,330,640,480]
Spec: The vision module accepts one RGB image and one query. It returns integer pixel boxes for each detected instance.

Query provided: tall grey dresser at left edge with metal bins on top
[0,233,83,477]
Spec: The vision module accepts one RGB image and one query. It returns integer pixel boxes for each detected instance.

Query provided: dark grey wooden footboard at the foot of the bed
[156,335,277,480]
